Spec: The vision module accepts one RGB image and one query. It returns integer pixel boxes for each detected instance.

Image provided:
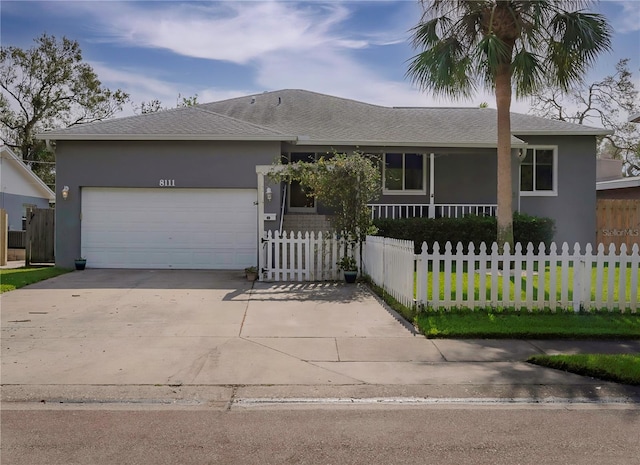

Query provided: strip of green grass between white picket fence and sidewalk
[415,310,640,339]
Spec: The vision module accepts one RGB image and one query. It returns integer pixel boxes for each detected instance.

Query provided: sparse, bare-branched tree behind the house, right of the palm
[531,58,640,176]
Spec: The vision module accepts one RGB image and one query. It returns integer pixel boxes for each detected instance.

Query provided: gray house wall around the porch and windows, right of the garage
[283,136,596,244]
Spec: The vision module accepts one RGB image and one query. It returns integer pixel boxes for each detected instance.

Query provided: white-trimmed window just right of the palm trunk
[520,147,558,195]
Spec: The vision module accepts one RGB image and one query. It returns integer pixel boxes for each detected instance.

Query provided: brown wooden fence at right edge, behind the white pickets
[596,199,640,250]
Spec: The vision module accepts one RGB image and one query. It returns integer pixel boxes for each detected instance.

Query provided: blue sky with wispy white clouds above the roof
[0,0,640,119]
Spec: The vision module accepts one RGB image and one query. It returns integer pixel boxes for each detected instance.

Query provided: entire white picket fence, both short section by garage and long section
[261,231,640,312]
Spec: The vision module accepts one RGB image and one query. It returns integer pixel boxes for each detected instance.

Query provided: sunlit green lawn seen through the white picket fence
[420,266,640,307]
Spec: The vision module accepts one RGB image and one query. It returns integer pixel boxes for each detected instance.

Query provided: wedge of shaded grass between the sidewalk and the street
[528,354,640,385]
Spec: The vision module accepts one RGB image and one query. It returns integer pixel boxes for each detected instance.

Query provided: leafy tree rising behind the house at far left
[0,34,129,186]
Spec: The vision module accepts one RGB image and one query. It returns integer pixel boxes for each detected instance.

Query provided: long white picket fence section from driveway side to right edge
[364,236,640,312]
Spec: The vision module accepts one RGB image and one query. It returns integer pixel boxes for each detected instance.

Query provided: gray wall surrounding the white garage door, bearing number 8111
[56,141,280,267]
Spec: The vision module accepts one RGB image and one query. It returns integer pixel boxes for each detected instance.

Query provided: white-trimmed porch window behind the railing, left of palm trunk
[382,153,427,194]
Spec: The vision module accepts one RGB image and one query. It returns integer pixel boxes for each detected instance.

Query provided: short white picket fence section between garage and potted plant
[261,231,360,282]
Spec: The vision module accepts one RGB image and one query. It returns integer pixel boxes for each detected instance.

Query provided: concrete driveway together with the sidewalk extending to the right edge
[1,270,640,401]
